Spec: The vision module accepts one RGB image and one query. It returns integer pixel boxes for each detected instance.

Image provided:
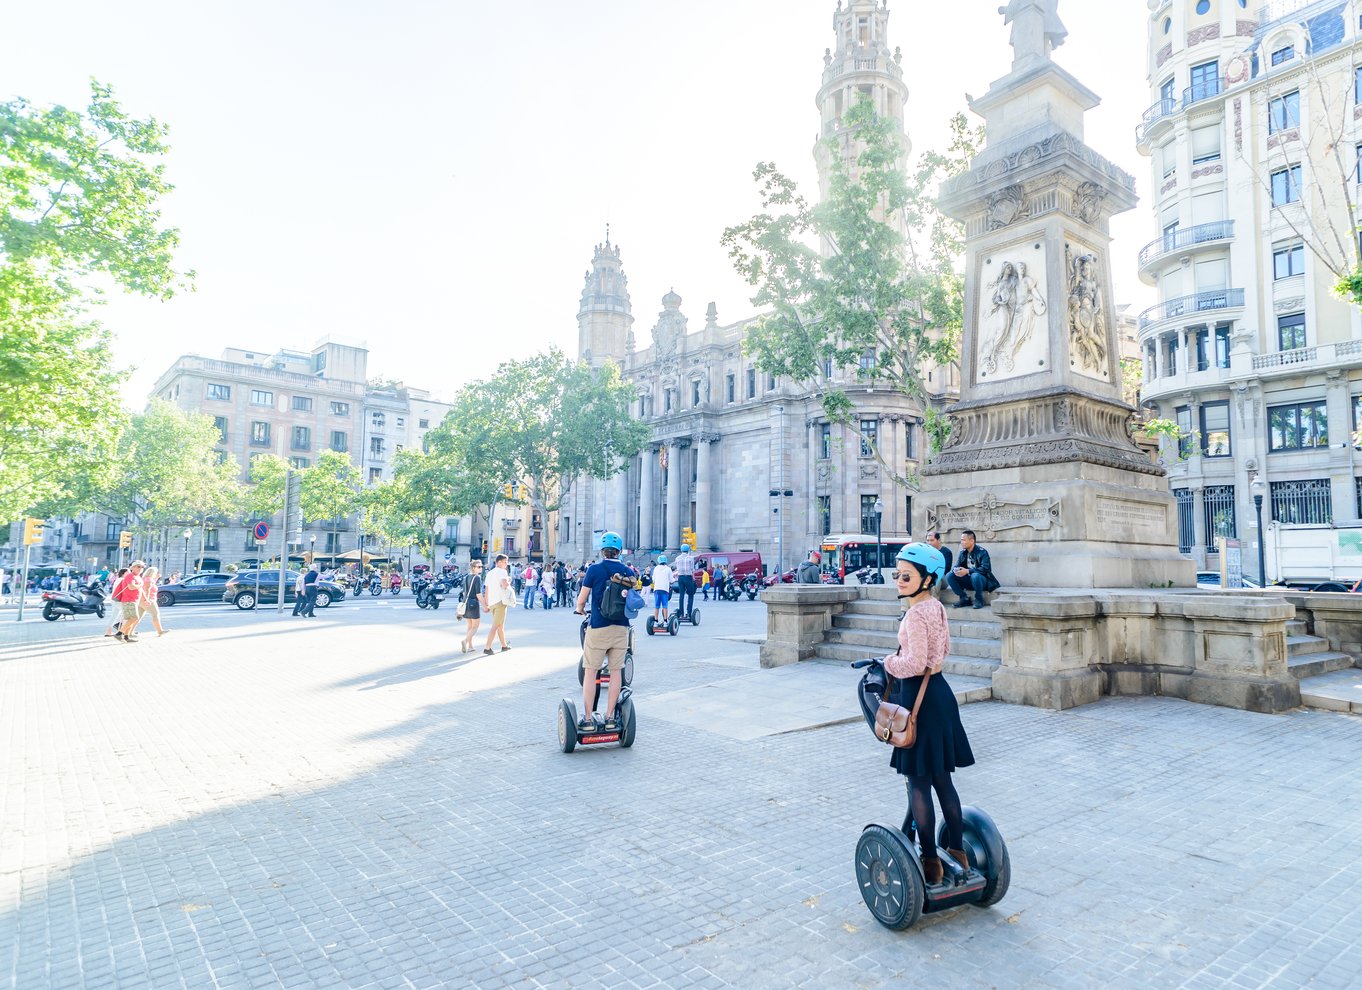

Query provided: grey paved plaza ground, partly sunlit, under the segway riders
[0,595,1362,990]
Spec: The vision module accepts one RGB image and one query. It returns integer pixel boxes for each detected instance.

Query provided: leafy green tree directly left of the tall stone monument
[723,99,982,468]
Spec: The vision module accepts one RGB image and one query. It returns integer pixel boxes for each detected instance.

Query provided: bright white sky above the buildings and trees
[0,0,1155,409]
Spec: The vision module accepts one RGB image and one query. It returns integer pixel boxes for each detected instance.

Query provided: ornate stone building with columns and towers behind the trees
[557,0,959,569]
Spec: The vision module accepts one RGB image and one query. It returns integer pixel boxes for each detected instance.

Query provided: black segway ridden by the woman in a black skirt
[851,659,1012,931]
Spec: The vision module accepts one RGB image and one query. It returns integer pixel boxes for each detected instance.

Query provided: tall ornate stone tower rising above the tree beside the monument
[813,0,911,197]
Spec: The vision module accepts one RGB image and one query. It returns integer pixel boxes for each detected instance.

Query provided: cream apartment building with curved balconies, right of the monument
[1136,0,1362,575]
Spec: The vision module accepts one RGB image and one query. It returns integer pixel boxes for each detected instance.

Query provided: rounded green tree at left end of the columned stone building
[426,347,648,560]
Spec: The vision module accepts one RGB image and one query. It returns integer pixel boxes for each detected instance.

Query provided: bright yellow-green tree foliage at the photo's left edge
[0,83,192,519]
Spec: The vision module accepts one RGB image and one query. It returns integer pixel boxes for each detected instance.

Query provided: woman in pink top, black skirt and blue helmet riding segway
[884,543,974,884]
